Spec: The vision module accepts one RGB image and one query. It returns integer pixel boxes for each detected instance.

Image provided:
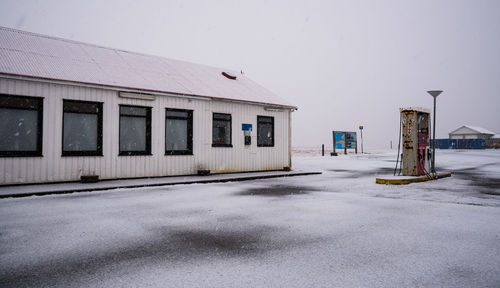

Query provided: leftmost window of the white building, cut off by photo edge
[0,94,43,157]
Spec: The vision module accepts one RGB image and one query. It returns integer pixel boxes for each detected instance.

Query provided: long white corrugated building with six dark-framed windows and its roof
[0,27,297,184]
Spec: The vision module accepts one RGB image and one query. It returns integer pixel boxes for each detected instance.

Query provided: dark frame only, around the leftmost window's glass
[0,94,44,157]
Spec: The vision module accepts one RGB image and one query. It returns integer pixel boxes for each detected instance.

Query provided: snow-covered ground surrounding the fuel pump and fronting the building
[0,150,500,287]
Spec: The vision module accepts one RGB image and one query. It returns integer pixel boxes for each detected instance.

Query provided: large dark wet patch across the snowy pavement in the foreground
[0,227,281,287]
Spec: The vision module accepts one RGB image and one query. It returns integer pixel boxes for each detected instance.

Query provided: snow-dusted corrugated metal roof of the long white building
[0,27,296,108]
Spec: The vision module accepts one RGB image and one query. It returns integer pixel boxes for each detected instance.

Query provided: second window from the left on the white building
[62,100,102,156]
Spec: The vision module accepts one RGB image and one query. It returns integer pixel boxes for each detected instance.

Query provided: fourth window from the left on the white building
[165,108,193,155]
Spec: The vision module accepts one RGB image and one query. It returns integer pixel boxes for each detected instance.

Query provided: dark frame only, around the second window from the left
[61,99,103,157]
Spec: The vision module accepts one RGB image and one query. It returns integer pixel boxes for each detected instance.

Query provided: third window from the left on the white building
[119,105,151,155]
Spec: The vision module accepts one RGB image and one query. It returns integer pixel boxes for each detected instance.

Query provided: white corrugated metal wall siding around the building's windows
[0,78,291,184]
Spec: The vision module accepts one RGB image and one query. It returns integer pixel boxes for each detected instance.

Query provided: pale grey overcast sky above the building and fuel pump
[0,0,500,148]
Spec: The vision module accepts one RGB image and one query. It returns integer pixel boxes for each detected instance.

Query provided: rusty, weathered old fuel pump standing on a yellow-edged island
[396,107,431,176]
